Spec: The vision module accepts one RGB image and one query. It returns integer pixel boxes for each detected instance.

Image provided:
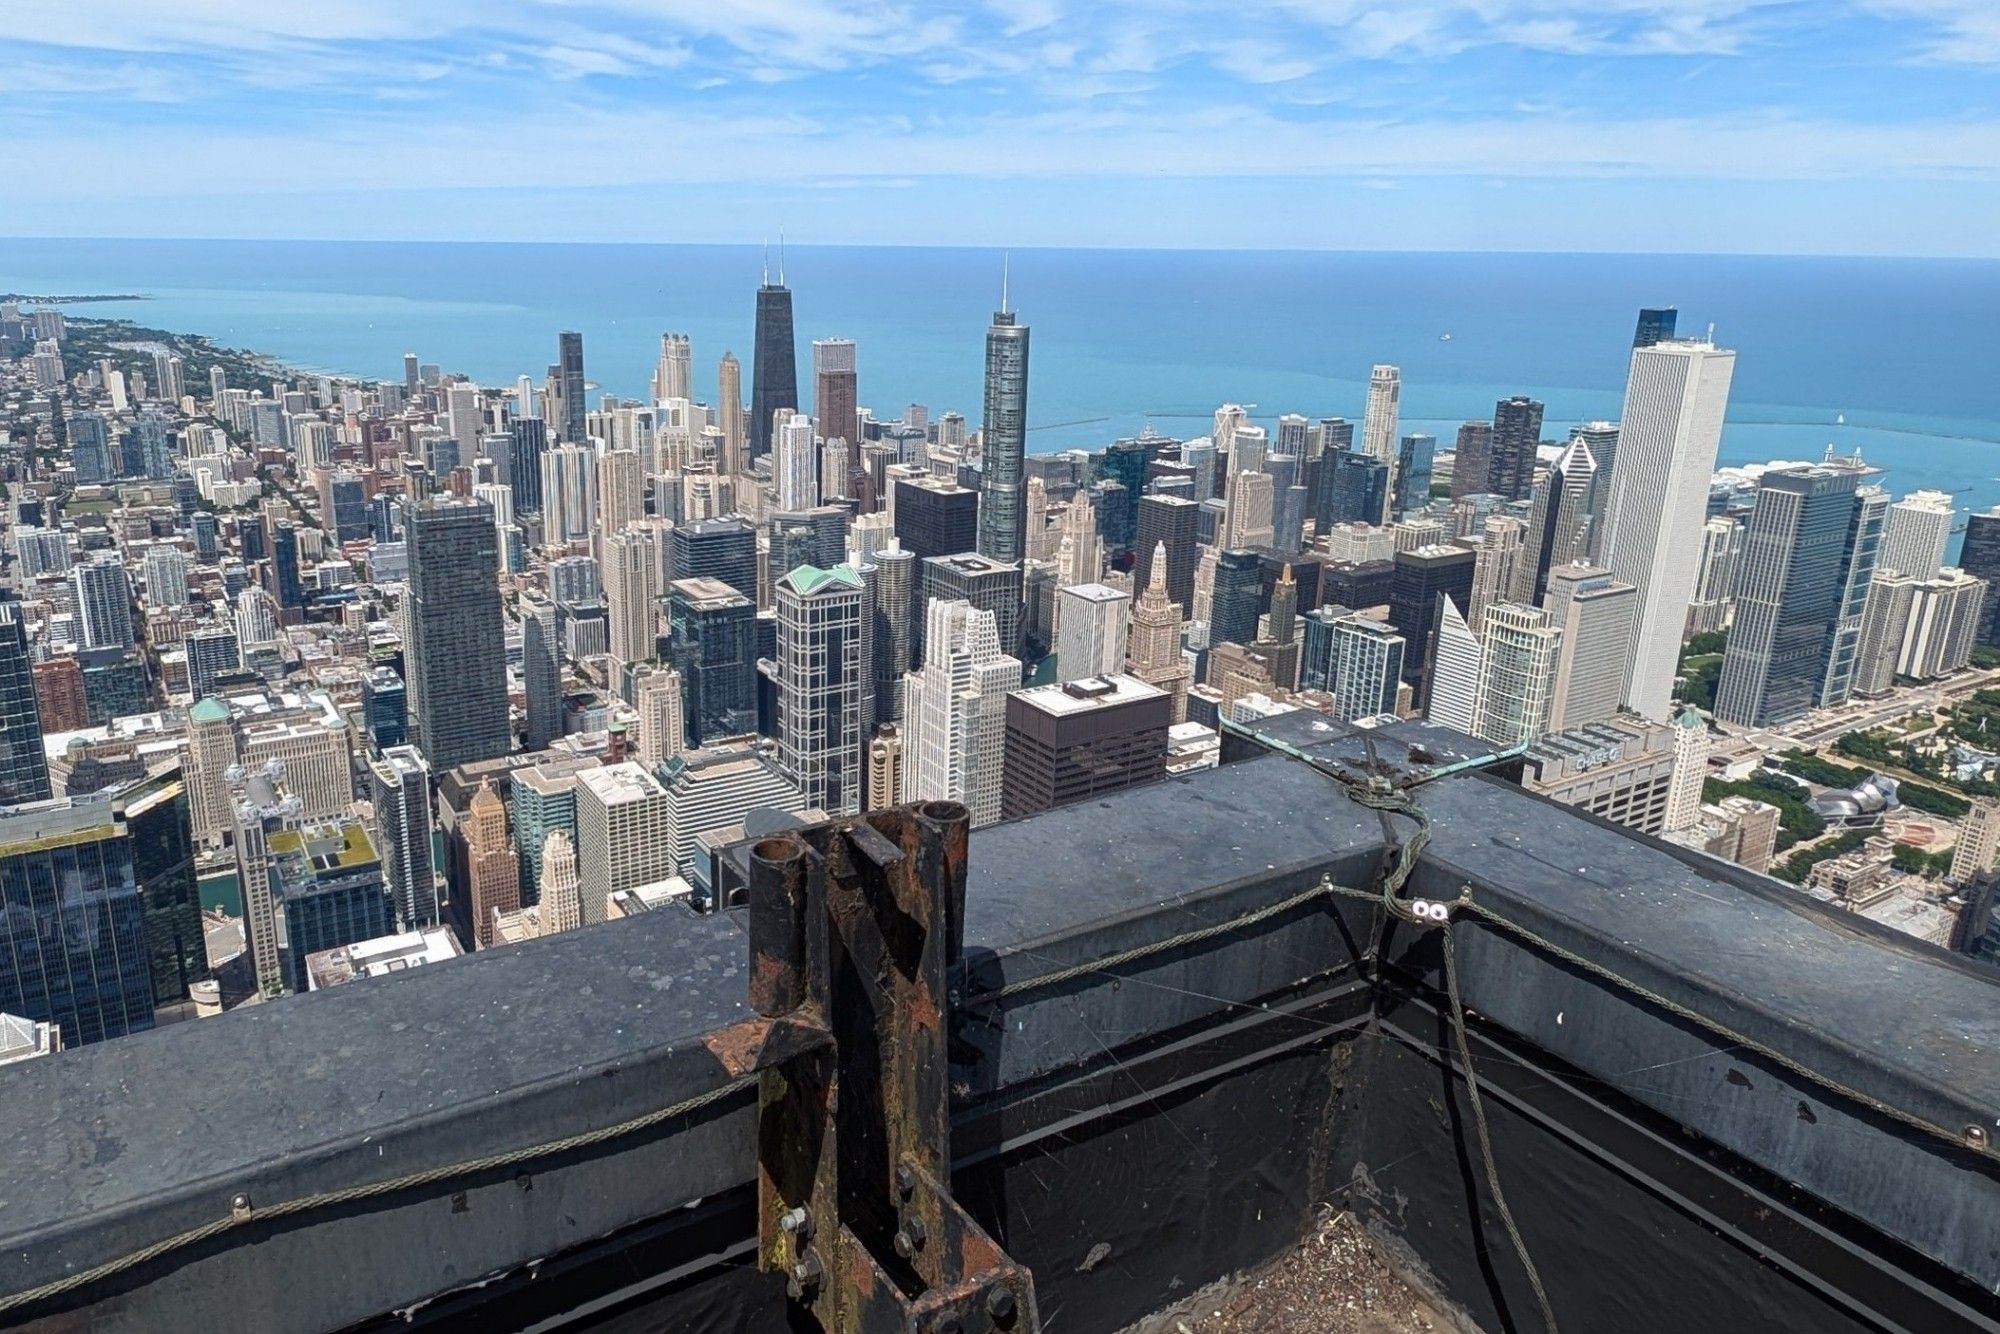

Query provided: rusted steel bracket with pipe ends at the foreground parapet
[750,802,1040,1334]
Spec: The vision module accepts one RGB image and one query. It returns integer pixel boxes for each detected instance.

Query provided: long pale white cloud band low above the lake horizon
[23,108,2000,198]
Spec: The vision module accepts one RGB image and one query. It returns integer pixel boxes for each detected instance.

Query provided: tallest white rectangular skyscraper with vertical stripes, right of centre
[1604,340,1736,722]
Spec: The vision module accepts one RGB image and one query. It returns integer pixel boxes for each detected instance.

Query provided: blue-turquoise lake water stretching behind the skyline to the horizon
[0,240,2000,536]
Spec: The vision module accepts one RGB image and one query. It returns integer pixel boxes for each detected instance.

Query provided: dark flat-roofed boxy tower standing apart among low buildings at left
[404,498,514,772]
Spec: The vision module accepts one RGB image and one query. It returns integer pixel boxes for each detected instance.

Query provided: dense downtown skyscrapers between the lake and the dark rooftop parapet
[0,274,2000,1042]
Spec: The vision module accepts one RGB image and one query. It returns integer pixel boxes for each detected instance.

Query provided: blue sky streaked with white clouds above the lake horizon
[0,0,2000,256]
